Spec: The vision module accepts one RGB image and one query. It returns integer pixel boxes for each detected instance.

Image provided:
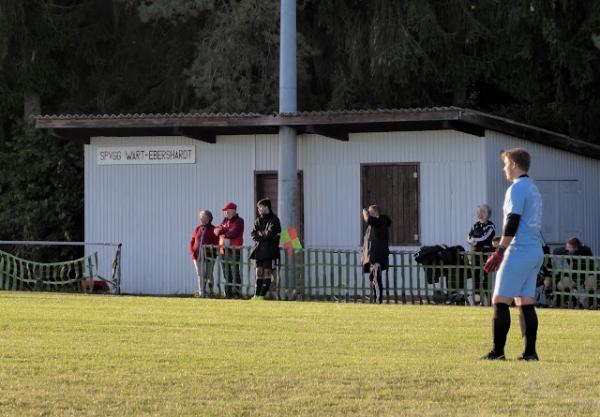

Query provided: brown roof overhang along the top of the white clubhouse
[35,107,600,159]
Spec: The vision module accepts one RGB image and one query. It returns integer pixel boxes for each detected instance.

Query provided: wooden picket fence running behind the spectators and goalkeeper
[199,247,600,308]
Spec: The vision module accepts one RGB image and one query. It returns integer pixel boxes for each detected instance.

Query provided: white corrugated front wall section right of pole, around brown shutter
[299,131,485,247]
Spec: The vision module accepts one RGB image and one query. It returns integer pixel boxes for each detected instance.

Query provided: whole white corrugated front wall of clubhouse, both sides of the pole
[85,131,486,294]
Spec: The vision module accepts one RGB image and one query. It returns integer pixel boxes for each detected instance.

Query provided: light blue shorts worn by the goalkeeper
[494,245,544,298]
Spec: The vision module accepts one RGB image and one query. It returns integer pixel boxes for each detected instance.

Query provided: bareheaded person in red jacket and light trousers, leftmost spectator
[190,210,219,297]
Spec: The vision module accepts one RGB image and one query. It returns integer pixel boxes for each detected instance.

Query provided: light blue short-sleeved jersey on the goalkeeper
[504,177,542,247]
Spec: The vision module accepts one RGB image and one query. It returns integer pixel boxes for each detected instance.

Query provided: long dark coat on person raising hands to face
[362,214,392,272]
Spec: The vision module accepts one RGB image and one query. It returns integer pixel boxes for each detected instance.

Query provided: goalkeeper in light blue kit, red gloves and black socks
[481,148,544,361]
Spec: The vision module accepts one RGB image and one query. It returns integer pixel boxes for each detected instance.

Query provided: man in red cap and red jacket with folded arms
[215,203,244,298]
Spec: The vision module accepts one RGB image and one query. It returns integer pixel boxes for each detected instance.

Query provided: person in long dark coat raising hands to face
[362,205,392,304]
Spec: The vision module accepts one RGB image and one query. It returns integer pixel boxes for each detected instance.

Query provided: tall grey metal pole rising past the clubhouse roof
[277,0,300,228]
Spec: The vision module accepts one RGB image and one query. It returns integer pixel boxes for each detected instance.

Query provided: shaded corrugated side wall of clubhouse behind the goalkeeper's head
[485,130,600,254]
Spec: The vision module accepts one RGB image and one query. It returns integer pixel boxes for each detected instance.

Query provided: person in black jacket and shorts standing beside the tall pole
[250,198,281,300]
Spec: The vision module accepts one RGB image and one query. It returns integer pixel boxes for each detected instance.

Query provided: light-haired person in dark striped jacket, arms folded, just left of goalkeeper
[467,204,496,305]
